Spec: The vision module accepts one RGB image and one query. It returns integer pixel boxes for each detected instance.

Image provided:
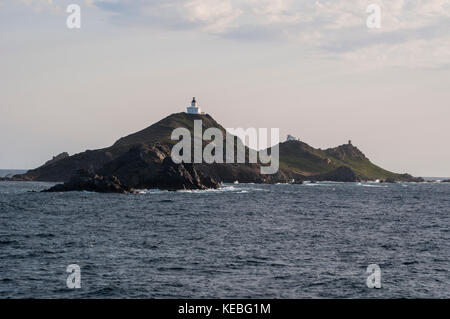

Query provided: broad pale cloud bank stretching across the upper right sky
[7,0,450,67]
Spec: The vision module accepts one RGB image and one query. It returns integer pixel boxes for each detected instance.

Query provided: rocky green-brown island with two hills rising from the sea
[14,113,422,189]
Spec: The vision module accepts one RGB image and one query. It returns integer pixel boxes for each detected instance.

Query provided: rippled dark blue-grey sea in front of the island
[0,182,450,298]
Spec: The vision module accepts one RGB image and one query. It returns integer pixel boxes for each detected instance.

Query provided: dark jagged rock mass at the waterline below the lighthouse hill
[41,145,219,193]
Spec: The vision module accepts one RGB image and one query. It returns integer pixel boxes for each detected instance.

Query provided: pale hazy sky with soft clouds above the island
[0,0,450,177]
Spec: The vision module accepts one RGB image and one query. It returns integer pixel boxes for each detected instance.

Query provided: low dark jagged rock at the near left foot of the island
[43,169,134,194]
